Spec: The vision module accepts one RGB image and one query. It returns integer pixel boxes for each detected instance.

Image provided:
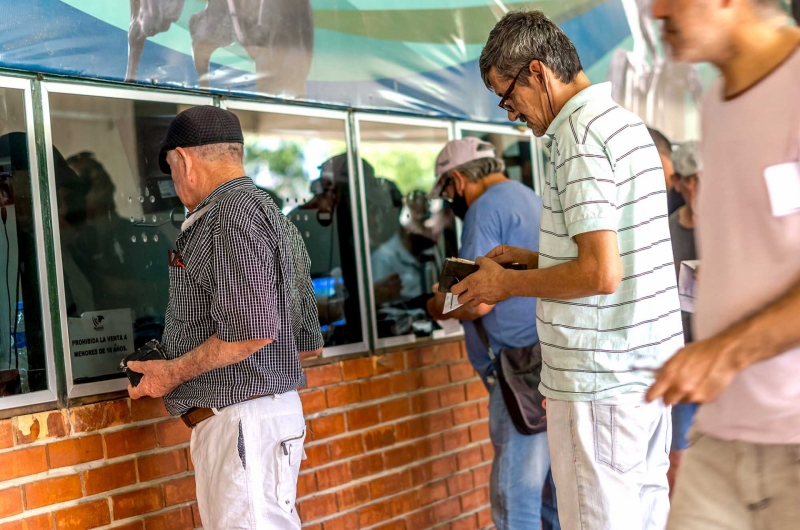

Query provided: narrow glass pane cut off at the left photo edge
[0,88,47,396]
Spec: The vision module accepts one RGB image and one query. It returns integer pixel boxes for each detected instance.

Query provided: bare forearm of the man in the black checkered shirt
[172,335,272,384]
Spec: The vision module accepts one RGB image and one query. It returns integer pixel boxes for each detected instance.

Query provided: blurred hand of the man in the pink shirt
[647,335,744,405]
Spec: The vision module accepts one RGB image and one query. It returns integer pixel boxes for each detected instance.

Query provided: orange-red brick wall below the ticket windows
[0,342,492,530]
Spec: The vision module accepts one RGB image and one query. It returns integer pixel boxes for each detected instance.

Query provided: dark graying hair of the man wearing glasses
[480,9,583,90]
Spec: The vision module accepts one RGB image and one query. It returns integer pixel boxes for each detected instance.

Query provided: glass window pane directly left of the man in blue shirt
[359,122,458,338]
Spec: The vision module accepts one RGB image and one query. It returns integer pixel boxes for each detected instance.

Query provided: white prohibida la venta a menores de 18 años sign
[68,309,133,380]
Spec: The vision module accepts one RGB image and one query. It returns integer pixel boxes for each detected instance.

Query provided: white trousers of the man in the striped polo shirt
[547,392,672,530]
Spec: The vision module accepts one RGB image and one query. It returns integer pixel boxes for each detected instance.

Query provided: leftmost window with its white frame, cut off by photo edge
[0,77,56,409]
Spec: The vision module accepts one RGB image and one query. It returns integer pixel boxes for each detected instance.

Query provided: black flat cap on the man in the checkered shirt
[158,105,244,175]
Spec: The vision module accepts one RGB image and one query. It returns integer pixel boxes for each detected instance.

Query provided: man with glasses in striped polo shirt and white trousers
[453,11,683,530]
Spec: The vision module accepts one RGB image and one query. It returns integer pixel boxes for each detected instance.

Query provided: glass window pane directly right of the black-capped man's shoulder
[233,111,363,347]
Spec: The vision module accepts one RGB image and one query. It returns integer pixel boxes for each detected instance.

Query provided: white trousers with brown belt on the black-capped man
[191,391,306,530]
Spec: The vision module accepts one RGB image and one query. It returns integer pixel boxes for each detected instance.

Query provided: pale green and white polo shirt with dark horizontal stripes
[536,83,683,401]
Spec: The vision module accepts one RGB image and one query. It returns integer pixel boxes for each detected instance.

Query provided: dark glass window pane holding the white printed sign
[50,94,195,383]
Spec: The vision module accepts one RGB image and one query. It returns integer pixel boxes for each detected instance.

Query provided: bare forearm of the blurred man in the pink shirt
[720,281,800,369]
